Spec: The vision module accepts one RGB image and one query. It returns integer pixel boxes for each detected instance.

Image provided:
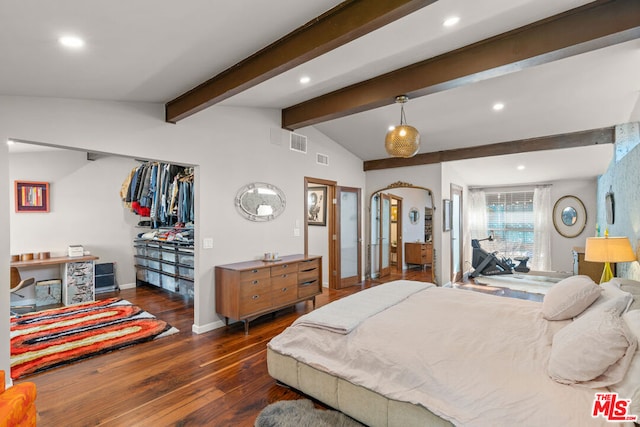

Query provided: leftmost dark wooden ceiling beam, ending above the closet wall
[165,0,437,123]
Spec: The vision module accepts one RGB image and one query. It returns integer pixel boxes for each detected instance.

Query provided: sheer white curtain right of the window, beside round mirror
[530,185,551,271]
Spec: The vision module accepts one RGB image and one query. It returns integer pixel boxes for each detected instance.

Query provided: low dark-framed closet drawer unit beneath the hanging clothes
[133,239,194,298]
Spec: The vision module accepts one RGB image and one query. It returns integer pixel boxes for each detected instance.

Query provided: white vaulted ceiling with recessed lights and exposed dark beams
[0,0,640,184]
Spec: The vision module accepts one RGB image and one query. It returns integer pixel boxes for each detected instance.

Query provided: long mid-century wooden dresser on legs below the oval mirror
[215,255,322,334]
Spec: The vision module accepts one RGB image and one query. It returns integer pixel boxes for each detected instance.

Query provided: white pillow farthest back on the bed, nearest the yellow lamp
[542,275,601,320]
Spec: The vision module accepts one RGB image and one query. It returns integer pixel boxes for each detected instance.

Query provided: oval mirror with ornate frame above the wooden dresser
[236,182,287,221]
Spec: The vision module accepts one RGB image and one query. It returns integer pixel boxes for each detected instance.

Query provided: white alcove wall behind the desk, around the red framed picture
[9,150,142,285]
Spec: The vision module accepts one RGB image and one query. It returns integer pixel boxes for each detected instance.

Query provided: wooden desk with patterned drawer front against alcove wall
[11,255,98,305]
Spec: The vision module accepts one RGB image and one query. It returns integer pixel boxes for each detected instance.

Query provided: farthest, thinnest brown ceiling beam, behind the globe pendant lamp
[363,127,615,171]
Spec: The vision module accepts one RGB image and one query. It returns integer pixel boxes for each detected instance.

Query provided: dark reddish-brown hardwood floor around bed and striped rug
[16,270,431,427]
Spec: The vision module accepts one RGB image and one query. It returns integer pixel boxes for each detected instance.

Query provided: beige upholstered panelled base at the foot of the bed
[267,348,453,427]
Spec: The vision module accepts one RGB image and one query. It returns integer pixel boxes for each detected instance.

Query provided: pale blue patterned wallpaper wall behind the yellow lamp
[597,122,640,280]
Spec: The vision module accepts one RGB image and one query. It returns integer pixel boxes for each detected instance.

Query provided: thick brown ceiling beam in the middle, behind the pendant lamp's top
[282,0,640,130]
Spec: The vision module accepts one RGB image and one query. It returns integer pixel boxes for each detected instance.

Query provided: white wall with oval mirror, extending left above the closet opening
[0,97,365,362]
